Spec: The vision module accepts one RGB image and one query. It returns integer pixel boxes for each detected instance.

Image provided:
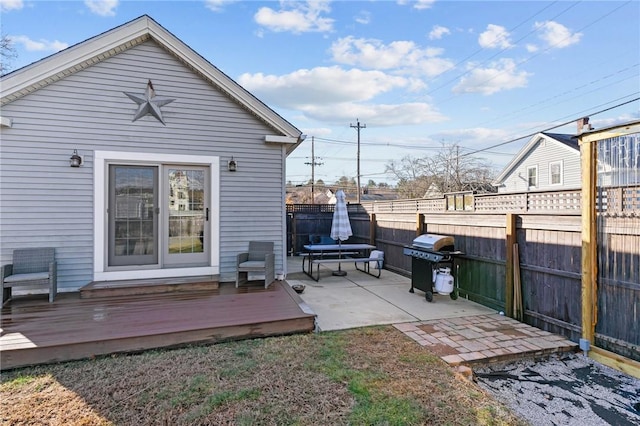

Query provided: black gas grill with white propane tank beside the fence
[402,234,462,302]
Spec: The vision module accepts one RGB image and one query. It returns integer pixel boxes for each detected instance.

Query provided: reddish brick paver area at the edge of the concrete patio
[394,314,578,366]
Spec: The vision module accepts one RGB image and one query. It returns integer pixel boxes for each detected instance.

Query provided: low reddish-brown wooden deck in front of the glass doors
[0,281,315,370]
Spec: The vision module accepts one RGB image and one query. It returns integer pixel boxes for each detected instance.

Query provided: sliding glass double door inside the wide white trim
[107,164,211,268]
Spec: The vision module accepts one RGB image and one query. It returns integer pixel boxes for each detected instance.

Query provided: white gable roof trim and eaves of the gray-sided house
[0,15,304,154]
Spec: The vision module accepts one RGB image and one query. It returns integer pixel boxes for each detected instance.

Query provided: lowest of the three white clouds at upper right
[453,59,531,95]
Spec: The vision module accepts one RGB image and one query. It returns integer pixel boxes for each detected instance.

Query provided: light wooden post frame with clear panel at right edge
[579,121,640,376]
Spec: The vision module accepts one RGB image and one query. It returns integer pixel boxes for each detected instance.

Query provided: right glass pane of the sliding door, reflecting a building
[168,168,206,254]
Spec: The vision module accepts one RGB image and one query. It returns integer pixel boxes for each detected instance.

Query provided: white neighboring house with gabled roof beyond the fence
[493,132,581,192]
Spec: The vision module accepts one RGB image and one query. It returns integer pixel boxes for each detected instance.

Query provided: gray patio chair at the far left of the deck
[0,247,58,304]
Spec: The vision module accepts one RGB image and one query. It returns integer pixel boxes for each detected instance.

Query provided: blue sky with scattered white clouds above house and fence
[0,0,640,185]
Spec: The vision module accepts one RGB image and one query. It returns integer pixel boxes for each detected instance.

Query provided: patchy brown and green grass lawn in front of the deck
[0,327,526,425]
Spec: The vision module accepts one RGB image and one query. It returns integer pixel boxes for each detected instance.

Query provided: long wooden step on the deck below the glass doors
[80,275,220,299]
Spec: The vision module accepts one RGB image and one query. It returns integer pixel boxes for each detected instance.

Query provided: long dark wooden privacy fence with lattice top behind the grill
[288,181,640,361]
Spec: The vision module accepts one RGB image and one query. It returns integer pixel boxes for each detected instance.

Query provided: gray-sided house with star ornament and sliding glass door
[0,15,304,291]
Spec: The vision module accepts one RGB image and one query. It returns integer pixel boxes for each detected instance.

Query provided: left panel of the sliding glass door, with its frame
[109,166,158,265]
